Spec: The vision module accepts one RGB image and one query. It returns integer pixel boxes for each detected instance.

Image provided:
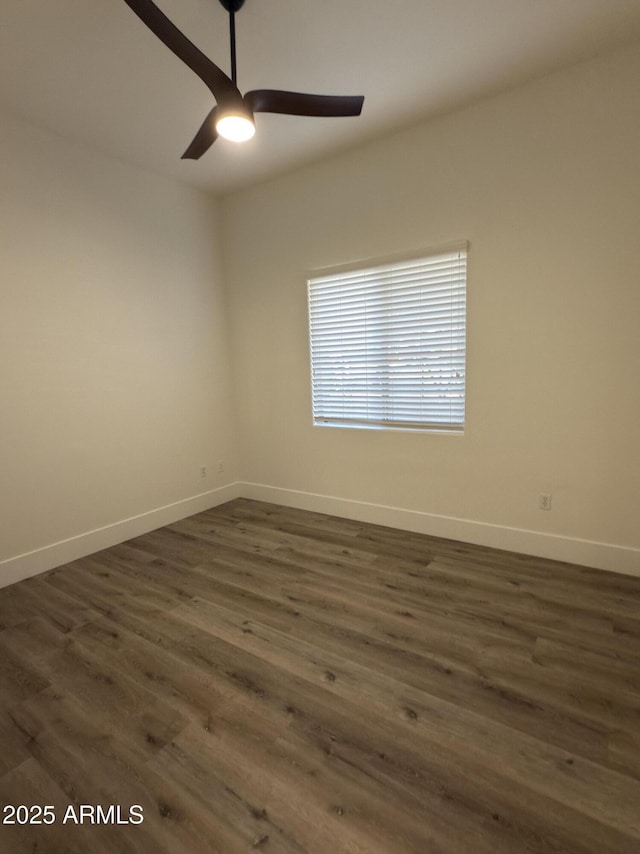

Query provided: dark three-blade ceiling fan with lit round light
[124,0,364,160]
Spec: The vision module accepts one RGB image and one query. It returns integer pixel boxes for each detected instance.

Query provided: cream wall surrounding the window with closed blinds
[223,47,640,570]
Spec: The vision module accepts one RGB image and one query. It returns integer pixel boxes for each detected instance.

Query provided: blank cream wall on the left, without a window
[0,117,237,584]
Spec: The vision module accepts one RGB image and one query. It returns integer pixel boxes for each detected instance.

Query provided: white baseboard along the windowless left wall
[0,483,242,587]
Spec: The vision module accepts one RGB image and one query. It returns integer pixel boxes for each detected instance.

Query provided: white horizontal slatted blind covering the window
[308,246,467,431]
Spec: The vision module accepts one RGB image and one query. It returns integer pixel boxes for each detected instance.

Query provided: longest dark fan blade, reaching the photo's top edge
[124,0,242,104]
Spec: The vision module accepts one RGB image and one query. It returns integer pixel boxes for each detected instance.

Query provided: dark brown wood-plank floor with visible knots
[0,500,640,854]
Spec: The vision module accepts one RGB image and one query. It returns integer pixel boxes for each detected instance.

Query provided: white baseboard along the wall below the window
[239,483,640,576]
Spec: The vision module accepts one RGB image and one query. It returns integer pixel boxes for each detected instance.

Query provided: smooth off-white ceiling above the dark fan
[0,0,640,192]
